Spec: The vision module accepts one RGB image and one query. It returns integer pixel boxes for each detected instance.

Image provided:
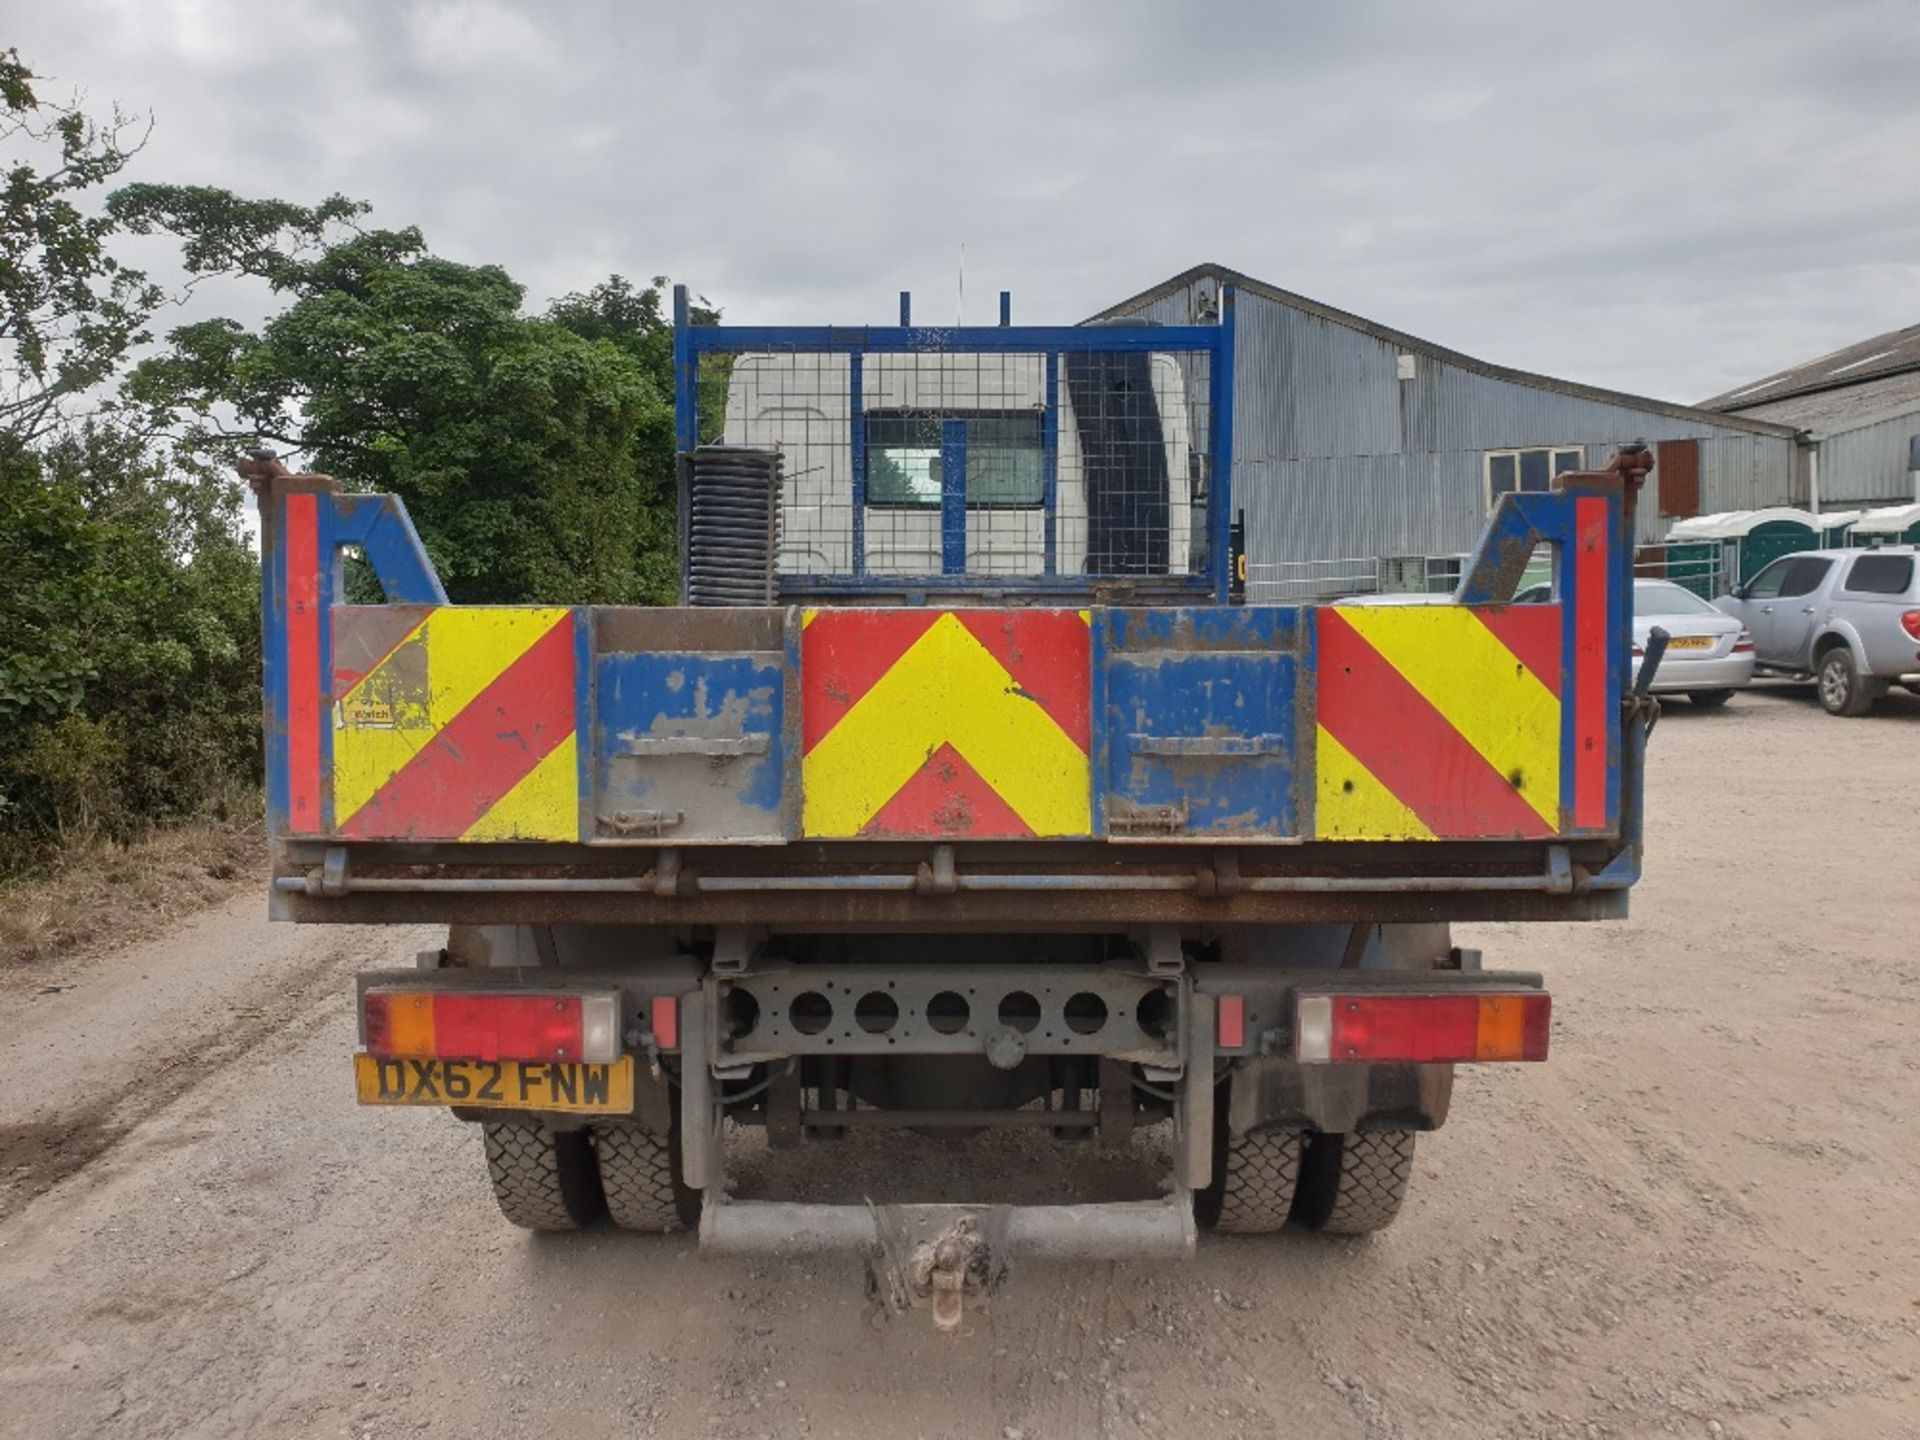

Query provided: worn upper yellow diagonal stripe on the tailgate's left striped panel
[334,605,572,833]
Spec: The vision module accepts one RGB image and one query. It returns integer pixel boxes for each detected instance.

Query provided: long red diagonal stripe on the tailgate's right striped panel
[1315,607,1551,839]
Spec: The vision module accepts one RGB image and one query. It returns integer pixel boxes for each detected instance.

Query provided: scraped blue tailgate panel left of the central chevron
[593,651,785,843]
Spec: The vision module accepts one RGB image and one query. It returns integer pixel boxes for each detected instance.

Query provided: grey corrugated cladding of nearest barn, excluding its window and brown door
[1135,278,1797,587]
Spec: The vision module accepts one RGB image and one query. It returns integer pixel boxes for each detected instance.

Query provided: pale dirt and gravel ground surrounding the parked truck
[0,689,1920,1440]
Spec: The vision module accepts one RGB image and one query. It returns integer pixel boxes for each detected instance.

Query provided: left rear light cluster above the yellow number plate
[361,989,620,1064]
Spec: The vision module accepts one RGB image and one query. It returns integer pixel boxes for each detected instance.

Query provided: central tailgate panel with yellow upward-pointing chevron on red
[801,611,1092,839]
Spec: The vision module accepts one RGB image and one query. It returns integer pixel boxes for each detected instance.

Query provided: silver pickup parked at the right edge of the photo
[1715,545,1920,714]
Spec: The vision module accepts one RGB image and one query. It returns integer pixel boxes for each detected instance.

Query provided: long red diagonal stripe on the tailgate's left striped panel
[340,614,574,839]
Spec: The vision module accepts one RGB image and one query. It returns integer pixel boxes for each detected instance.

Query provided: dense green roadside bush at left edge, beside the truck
[0,422,259,862]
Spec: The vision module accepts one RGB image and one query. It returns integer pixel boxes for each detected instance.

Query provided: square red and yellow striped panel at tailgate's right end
[1315,605,1561,839]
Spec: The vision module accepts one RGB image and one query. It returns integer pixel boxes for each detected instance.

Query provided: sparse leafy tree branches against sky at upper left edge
[0,50,163,442]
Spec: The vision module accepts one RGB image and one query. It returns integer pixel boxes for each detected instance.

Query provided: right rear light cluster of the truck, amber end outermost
[1294,991,1553,1064]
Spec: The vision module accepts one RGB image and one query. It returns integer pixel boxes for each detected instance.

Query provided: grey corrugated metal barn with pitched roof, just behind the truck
[1094,265,1795,601]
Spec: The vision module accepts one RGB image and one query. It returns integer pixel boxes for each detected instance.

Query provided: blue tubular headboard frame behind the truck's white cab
[674,286,1235,605]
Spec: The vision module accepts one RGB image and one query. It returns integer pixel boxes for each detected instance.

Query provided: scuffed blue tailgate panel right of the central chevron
[1096,607,1302,839]
